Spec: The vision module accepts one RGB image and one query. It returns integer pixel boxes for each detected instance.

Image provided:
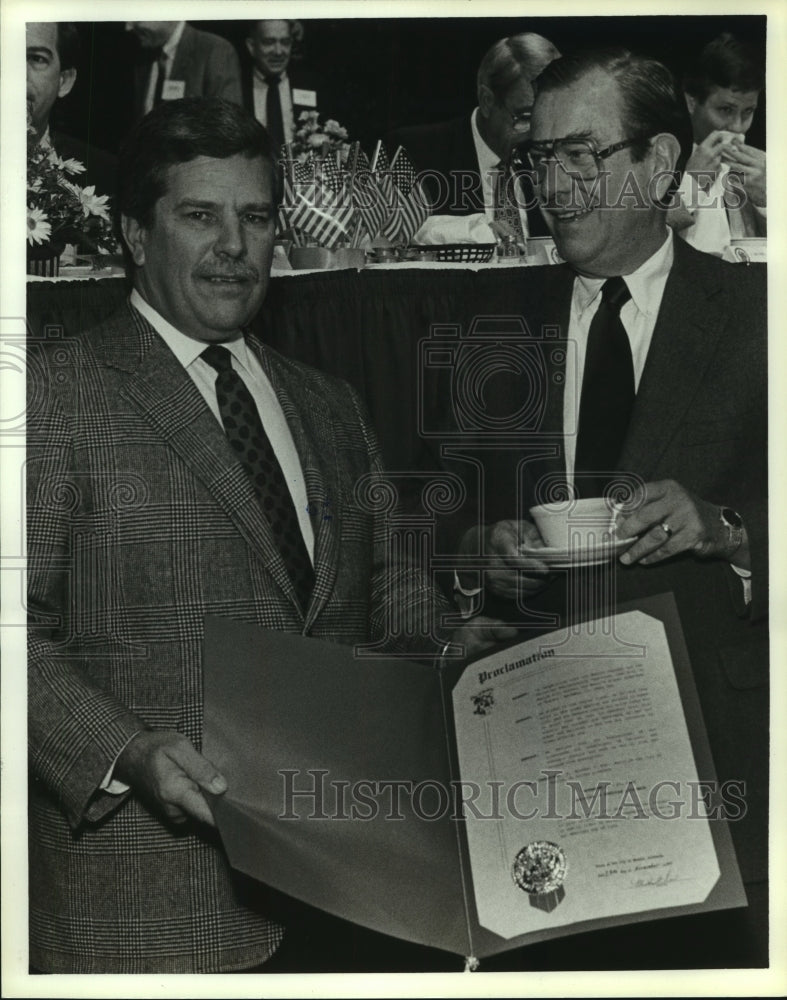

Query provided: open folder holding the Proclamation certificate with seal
[203,596,746,958]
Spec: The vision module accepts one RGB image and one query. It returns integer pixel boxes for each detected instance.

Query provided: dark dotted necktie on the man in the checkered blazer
[201,344,314,611]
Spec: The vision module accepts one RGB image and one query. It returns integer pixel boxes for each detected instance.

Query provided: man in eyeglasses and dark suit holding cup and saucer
[452,50,768,968]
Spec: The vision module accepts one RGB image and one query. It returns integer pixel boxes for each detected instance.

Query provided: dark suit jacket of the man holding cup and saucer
[440,239,768,965]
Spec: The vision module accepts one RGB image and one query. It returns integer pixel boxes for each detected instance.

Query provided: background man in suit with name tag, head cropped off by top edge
[126,21,241,118]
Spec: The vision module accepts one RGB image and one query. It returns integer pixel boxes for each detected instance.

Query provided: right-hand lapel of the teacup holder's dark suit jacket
[619,239,726,480]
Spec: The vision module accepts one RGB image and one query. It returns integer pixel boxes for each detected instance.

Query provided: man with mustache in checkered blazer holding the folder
[27,98,510,973]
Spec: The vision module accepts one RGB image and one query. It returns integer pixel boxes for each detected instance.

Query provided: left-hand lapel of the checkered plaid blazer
[104,309,308,607]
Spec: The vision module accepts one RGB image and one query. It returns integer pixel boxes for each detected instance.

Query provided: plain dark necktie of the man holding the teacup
[574,278,634,497]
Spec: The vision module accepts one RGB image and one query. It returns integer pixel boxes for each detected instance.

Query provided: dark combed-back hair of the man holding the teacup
[534,48,692,172]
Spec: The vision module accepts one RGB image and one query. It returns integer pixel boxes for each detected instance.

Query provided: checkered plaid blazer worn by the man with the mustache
[27,306,444,973]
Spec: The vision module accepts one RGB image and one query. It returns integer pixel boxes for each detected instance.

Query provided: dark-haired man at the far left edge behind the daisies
[26,21,117,195]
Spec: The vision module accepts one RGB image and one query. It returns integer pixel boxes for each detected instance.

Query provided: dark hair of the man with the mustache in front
[115,97,280,227]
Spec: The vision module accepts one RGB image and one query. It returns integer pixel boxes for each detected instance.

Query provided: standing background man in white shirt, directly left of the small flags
[242,21,326,148]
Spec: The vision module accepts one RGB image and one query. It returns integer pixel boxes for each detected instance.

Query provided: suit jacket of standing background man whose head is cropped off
[134,24,241,118]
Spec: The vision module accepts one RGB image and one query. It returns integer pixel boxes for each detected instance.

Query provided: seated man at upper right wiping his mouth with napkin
[676,33,767,254]
